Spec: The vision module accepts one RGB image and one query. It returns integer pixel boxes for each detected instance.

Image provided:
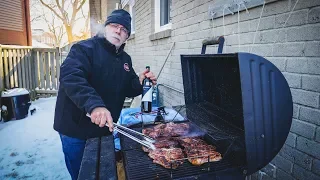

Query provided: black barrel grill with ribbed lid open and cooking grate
[120,53,293,180]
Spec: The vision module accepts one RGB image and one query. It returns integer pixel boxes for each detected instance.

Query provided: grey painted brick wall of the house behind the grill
[126,0,320,180]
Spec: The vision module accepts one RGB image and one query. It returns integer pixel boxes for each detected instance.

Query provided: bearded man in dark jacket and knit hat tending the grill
[54,9,156,179]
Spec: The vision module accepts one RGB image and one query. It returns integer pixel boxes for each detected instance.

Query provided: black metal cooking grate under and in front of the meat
[120,124,240,180]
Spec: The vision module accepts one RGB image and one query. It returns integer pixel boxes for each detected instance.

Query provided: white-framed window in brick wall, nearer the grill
[154,0,172,32]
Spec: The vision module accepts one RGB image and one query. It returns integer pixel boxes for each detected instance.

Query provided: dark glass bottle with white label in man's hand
[141,66,152,113]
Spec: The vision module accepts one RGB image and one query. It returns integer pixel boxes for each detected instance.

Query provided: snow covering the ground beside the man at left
[0,97,71,180]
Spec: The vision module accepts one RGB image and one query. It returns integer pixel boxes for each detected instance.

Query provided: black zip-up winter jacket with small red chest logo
[53,36,142,139]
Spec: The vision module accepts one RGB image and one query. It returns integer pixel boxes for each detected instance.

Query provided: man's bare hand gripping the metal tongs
[91,107,113,132]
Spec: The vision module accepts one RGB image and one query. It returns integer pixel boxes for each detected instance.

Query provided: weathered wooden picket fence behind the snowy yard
[0,45,61,99]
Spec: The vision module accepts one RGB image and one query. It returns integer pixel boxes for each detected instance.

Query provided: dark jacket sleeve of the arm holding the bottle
[126,64,142,97]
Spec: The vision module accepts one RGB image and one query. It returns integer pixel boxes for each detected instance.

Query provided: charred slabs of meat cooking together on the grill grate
[142,122,222,169]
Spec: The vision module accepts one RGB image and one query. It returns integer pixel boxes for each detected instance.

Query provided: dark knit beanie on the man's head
[104,9,131,37]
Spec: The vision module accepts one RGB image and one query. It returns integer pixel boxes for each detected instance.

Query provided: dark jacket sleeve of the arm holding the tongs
[59,44,105,113]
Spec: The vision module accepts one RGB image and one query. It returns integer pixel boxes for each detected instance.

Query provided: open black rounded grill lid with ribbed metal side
[181,53,293,174]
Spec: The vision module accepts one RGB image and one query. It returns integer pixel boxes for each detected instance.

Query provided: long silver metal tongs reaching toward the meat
[87,114,156,150]
